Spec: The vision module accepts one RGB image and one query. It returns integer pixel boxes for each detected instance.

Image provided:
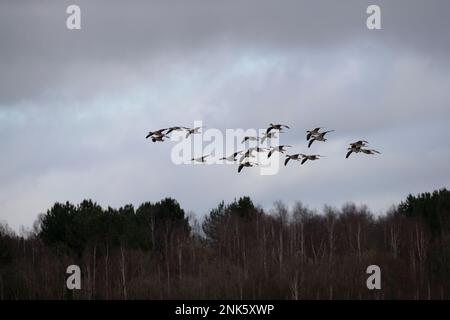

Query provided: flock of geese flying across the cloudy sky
[145,123,380,172]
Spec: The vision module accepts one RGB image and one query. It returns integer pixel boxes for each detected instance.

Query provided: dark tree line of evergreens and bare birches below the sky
[0,189,450,299]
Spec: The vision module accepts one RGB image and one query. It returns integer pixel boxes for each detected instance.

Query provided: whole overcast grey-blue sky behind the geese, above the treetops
[0,0,450,230]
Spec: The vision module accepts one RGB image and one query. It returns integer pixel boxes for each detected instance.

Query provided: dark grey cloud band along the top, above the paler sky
[0,0,450,105]
